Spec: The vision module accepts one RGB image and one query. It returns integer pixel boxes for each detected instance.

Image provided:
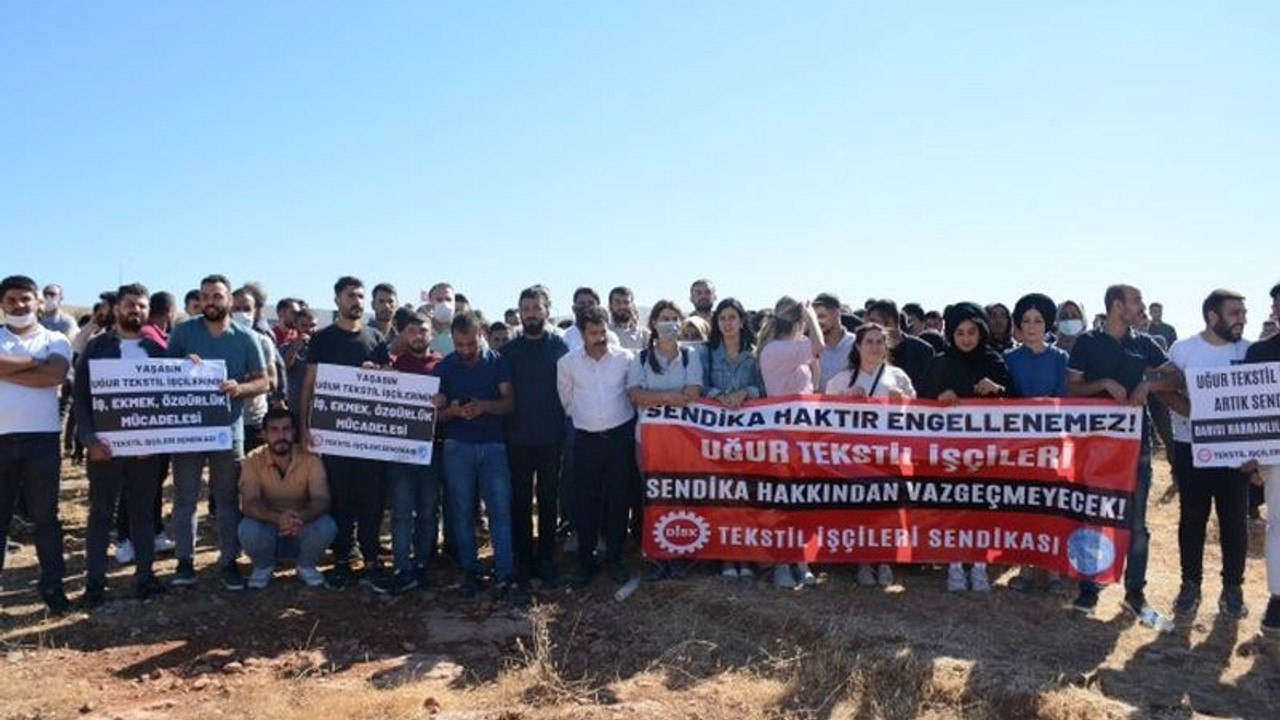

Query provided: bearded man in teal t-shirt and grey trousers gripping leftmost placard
[168,274,270,591]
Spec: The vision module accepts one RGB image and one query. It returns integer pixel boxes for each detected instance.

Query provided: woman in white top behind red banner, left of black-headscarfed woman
[826,323,915,588]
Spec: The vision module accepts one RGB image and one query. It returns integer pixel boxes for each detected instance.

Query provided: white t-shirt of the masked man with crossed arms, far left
[0,324,72,434]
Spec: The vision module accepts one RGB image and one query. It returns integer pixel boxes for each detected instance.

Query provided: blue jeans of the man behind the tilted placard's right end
[387,457,440,574]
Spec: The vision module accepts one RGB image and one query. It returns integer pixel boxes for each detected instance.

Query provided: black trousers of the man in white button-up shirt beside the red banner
[573,423,635,573]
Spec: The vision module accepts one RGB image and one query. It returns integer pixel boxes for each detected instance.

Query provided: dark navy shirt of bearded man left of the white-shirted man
[502,332,568,446]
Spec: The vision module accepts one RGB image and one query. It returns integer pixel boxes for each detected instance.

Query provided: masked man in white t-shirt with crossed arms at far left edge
[0,275,72,614]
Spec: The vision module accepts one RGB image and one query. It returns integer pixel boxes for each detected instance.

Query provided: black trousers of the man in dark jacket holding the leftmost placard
[84,456,166,585]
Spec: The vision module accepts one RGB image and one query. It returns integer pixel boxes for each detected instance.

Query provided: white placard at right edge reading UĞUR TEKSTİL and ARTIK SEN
[1187,363,1280,468]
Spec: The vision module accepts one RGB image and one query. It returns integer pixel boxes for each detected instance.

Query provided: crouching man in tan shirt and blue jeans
[239,407,338,589]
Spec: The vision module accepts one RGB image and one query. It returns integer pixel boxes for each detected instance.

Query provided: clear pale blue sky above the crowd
[0,0,1280,337]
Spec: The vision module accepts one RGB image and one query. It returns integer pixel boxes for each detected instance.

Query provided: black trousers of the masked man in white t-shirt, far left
[0,432,67,594]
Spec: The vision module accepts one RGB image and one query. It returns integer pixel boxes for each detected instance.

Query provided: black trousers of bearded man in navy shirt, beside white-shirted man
[507,443,562,580]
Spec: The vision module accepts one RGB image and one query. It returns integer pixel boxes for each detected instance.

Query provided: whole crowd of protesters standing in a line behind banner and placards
[0,274,1280,630]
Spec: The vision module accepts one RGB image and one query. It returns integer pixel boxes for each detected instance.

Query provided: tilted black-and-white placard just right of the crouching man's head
[308,364,440,465]
